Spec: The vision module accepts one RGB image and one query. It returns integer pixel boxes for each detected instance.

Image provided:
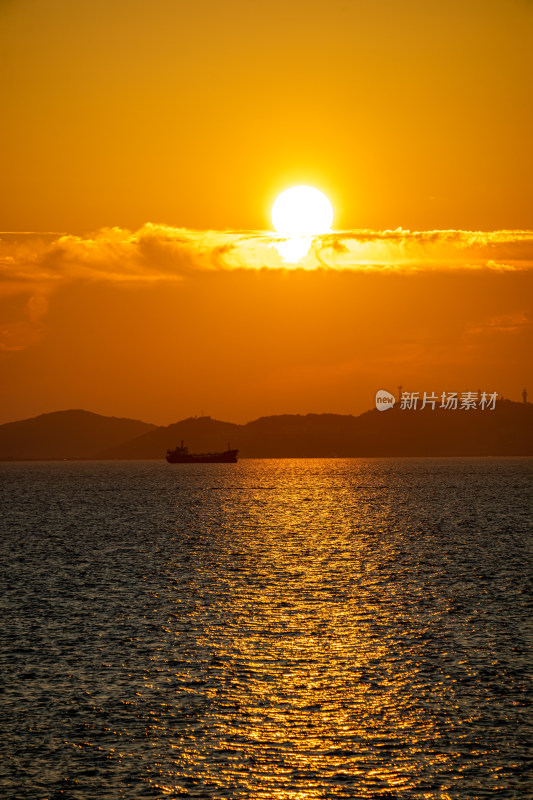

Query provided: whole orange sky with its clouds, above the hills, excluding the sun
[0,0,533,424]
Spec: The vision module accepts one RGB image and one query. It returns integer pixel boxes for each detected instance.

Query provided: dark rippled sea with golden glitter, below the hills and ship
[0,459,533,800]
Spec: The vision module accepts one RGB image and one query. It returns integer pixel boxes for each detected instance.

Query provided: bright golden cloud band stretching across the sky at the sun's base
[0,223,533,292]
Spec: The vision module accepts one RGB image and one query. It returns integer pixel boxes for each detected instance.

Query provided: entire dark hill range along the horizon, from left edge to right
[0,400,533,459]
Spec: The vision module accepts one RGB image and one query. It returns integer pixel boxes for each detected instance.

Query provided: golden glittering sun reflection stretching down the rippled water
[131,465,528,798]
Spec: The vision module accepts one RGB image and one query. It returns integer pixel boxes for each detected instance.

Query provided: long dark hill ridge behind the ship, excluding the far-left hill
[99,400,533,458]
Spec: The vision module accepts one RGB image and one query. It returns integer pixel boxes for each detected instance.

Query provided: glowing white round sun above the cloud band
[271,186,333,236]
